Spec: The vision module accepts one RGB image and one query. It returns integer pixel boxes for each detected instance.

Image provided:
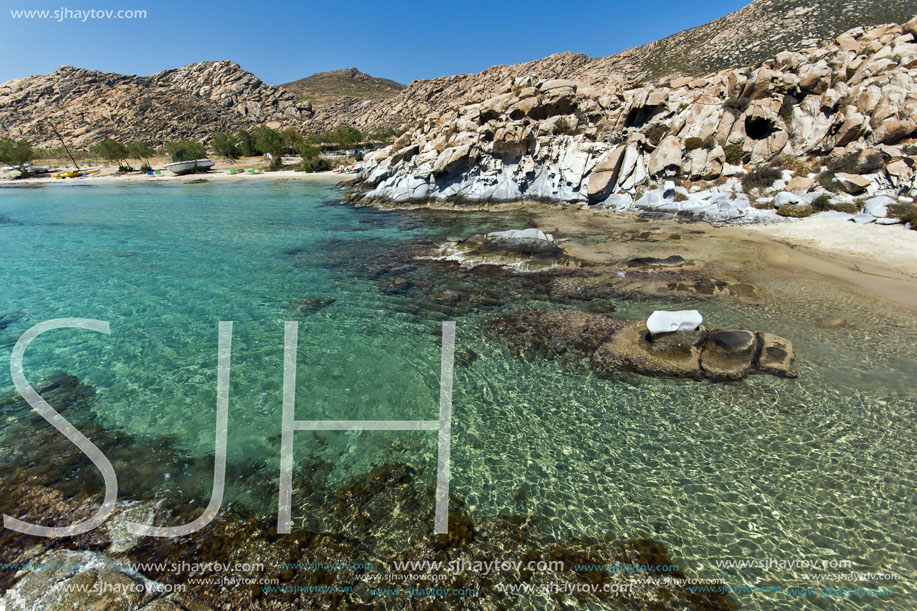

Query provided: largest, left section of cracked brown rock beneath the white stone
[592,320,707,378]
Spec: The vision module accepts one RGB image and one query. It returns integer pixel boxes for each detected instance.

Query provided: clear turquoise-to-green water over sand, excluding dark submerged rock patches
[0,183,917,609]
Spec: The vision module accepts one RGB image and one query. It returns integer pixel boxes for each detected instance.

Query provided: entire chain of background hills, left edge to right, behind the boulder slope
[0,0,917,148]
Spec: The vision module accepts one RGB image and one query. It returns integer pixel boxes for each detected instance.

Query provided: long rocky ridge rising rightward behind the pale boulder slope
[314,0,917,128]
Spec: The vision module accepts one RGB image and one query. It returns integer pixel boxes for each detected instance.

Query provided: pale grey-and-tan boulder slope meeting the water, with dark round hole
[357,18,917,225]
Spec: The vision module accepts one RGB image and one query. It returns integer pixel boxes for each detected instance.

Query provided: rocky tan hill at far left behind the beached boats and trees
[0,61,312,148]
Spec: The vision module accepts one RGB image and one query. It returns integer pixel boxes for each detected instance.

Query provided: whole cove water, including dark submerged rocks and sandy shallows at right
[0,184,917,610]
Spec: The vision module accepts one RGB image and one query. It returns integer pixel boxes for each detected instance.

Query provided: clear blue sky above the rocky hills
[0,0,747,85]
